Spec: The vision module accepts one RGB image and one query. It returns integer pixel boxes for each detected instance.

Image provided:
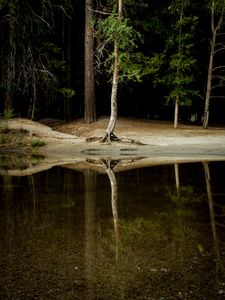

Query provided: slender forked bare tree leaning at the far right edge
[203,0,225,129]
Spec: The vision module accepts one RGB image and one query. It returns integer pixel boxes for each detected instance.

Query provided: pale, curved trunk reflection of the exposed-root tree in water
[106,161,119,260]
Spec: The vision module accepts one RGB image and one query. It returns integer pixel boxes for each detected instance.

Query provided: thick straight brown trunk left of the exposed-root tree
[84,0,96,123]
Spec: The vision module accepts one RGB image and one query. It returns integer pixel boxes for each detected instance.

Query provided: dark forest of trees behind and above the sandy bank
[0,0,225,130]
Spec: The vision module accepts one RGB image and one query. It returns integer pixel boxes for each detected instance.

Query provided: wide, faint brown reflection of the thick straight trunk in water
[84,170,96,299]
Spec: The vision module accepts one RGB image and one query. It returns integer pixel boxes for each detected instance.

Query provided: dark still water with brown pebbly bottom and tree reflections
[0,162,225,300]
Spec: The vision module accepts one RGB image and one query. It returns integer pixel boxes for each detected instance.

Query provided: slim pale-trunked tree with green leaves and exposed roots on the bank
[96,0,148,142]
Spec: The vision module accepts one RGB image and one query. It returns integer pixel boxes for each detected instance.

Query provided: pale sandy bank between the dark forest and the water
[0,117,225,175]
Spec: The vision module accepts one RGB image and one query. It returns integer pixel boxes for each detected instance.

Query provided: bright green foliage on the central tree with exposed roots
[95,14,152,82]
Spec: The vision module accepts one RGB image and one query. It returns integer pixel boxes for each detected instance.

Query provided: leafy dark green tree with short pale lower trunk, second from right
[165,0,197,128]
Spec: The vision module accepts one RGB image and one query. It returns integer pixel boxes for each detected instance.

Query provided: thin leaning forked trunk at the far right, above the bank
[203,1,224,129]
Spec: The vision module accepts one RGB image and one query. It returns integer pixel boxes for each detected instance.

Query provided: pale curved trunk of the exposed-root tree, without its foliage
[101,0,122,142]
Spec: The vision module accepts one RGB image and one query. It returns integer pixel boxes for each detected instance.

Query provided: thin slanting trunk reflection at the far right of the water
[203,162,220,269]
